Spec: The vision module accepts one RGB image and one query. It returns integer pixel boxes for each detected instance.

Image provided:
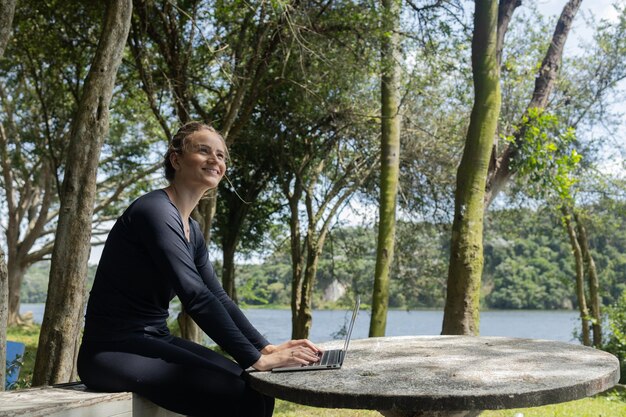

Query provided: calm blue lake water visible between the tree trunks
[20,304,580,343]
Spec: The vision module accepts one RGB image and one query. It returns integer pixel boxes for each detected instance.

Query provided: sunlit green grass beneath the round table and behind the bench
[7,325,626,417]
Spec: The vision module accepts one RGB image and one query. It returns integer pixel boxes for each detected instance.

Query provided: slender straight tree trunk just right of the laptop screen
[369,0,402,337]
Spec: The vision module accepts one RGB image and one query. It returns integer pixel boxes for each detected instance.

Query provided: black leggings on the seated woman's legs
[78,336,274,417]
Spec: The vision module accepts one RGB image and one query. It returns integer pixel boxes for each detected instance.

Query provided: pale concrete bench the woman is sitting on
[0,383,184,417]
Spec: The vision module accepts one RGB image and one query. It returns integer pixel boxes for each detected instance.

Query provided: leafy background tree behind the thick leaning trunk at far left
[0,0,158,324]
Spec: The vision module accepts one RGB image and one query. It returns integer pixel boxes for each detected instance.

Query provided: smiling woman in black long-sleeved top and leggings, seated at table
[78,122,320,417]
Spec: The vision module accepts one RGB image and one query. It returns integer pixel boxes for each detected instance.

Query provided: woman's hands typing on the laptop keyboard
[252,339,322,371]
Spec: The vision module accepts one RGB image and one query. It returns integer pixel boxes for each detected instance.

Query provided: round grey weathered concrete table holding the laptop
[250,336,619,417]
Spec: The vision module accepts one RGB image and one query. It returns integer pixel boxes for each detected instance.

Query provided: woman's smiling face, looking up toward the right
[171,130,227,189]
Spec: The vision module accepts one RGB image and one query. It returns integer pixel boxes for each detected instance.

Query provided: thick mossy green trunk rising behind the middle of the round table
[442,0,500,335]
